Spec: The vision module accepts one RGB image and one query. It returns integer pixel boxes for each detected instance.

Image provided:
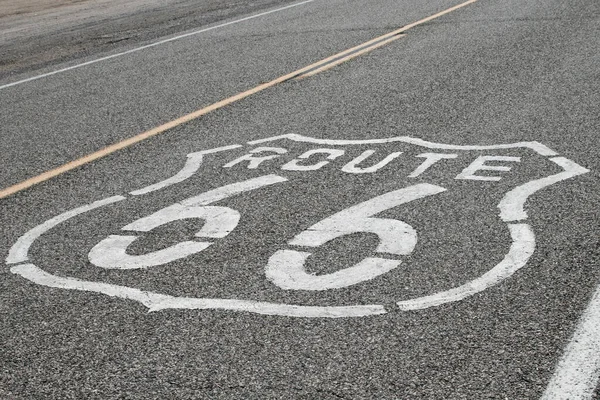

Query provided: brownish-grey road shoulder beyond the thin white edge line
[0,0,302,79]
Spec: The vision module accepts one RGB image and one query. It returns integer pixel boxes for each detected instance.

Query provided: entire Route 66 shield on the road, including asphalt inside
[6,134,588,318]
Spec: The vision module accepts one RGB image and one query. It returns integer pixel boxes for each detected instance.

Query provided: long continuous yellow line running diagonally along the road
[0,0,478,199]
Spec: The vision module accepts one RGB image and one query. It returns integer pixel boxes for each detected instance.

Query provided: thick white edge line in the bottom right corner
[542,286,600,400]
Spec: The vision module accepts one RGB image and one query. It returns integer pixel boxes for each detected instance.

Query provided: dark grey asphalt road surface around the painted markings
[0,0,600,399]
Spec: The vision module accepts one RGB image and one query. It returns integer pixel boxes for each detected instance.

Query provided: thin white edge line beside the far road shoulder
[0,0,316,90]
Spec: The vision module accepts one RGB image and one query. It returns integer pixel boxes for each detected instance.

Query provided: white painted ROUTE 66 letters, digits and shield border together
[6,134,589,318]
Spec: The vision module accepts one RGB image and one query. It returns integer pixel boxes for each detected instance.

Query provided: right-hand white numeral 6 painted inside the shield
[265,183,446,290]
